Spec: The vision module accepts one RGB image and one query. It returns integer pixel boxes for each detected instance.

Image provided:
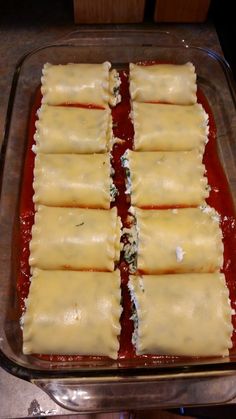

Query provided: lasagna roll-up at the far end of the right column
[129,63,197,105]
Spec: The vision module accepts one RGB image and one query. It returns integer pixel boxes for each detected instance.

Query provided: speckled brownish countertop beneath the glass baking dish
[0,22,234,419]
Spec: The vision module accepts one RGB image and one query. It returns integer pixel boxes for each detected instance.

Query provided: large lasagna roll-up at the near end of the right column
[129,273,233,356]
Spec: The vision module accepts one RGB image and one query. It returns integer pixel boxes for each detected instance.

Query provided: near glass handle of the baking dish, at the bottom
[33,374,236,413]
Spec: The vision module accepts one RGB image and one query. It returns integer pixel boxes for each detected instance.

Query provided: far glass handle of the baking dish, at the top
[56,28,188,47]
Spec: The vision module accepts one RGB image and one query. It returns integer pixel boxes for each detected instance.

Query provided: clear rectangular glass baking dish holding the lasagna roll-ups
[0,31,236,412]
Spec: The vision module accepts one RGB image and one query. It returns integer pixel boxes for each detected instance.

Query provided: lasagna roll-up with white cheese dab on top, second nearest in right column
[124,207,223,274]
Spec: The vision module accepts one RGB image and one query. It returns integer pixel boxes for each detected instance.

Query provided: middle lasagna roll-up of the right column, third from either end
[122,150,209,208]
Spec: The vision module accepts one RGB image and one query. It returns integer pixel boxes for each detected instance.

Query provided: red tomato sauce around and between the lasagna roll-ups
[17,69,236,365]
